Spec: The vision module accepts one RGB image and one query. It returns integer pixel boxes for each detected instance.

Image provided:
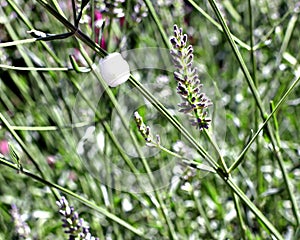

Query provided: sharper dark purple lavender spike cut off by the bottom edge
[56,197,99,240]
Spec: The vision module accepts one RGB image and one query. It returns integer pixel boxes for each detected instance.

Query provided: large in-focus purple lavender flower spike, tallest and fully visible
[170,25,212,130]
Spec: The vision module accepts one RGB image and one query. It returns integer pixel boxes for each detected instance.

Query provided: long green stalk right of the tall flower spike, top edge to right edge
[209,0,300,227]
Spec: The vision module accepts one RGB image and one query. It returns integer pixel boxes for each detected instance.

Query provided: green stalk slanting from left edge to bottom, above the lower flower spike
[0,157,145,238]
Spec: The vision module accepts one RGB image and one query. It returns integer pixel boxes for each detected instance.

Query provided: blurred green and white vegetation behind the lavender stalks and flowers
[0,0,300,239]
